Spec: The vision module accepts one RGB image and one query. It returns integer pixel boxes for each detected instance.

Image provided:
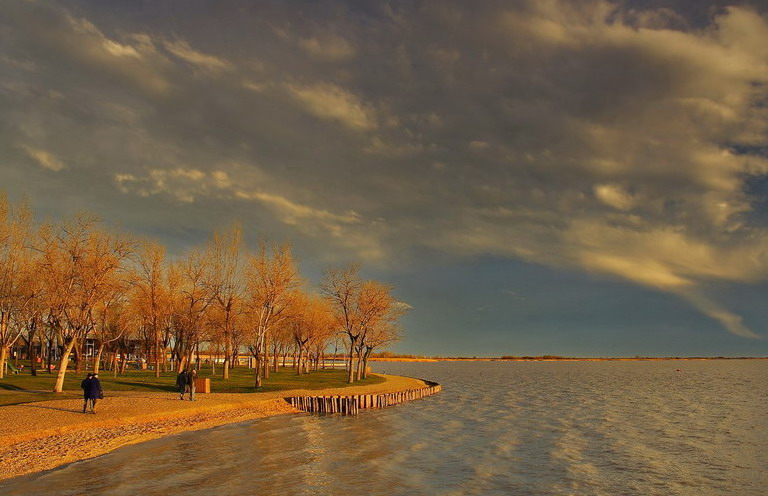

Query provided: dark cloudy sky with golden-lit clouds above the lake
[0,0,768,356]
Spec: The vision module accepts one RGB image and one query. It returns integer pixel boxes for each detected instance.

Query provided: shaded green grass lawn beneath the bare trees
[0,364,384,406]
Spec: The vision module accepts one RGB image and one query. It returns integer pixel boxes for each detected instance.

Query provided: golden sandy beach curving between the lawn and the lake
[0,374,433,481]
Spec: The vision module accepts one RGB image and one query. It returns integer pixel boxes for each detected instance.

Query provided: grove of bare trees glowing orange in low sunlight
[0,194,409,392]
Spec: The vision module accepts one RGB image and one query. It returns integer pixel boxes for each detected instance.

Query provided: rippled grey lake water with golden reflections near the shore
[0,360,768,496]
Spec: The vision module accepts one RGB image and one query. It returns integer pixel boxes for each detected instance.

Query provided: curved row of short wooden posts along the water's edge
[285,381,441,415]
